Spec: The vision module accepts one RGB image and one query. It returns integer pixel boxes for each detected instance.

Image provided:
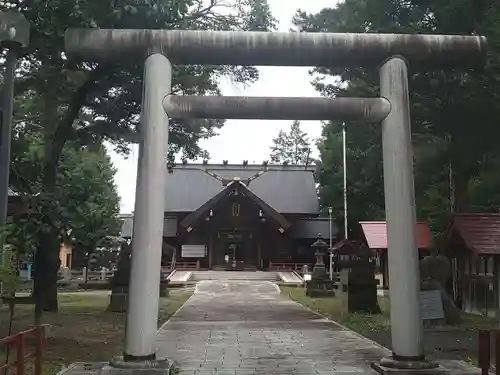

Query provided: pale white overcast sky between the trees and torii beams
[110,0,336,213]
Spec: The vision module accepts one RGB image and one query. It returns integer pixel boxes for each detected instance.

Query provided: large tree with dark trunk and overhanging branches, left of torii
[2,0,275,316]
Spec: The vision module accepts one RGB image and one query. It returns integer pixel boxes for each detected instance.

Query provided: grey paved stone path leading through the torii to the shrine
[154,280,389,375]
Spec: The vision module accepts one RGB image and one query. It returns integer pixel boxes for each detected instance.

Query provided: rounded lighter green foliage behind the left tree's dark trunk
[9,133,120,258]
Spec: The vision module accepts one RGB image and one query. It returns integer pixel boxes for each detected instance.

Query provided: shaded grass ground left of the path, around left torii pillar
[0,289,193,375]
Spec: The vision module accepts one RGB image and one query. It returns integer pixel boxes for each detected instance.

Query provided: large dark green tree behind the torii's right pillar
[295,0,500,235]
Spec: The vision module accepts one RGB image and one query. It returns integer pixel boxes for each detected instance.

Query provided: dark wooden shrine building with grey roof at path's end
[124,162,338,270]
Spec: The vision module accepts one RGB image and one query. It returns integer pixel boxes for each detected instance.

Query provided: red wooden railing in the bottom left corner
[0,326,44,375]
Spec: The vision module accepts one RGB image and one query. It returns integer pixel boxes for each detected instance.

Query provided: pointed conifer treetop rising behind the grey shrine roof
[270,121,311,164]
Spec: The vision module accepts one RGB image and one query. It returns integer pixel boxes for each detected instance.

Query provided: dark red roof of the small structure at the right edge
[451,213,500,255]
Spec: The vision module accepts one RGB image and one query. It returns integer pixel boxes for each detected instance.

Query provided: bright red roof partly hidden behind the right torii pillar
[359,221,431,249]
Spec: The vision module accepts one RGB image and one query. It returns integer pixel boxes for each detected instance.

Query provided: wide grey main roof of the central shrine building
[165,164,319,215]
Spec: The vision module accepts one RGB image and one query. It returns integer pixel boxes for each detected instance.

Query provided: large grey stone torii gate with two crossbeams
[66,29,486,374]
